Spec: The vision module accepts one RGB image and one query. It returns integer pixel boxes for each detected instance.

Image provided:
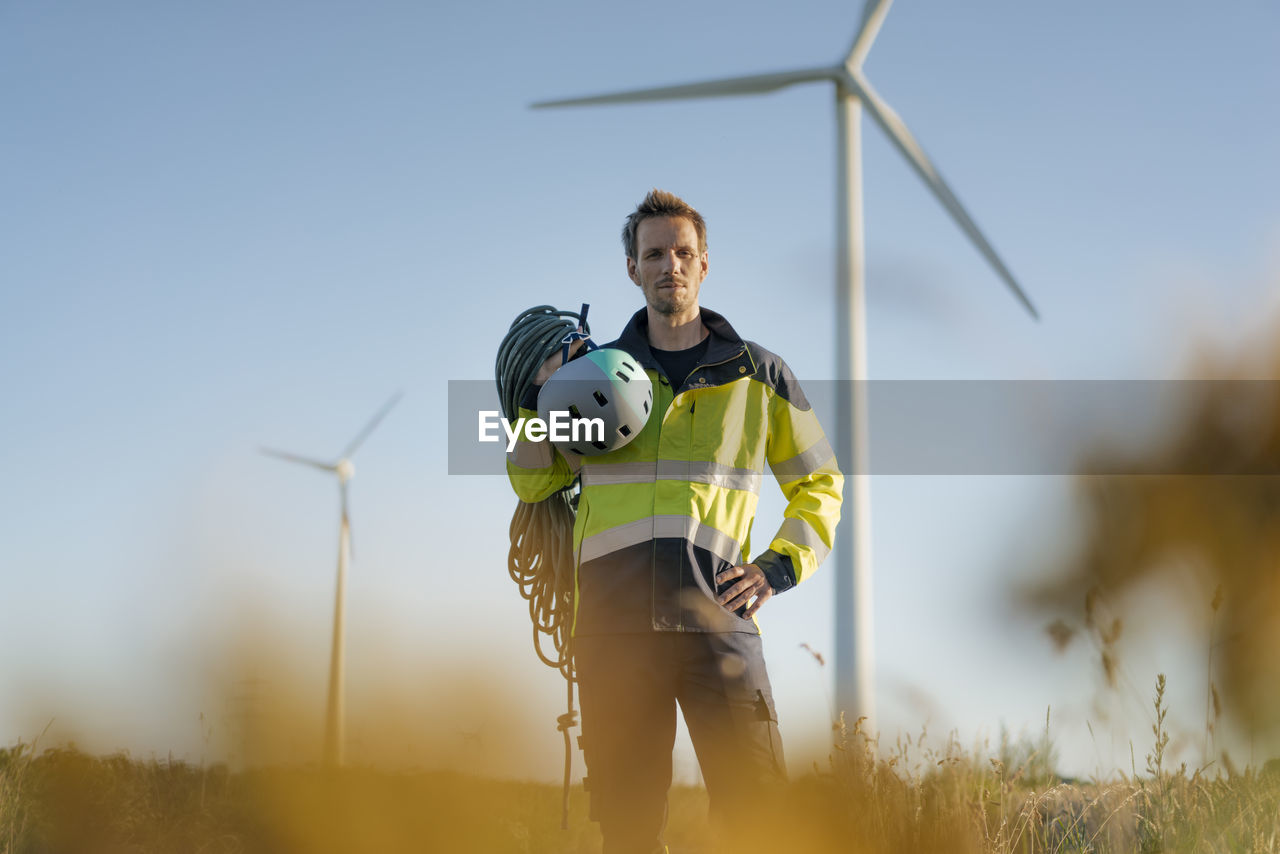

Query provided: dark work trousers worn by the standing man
[573,631,786,854]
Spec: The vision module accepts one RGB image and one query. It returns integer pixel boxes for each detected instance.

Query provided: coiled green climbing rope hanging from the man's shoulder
[494,305,591,830]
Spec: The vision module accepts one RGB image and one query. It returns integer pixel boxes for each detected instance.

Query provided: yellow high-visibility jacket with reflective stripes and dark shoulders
[507,309,844,635]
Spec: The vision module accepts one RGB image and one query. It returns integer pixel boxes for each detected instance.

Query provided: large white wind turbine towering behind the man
[532,0,1039,732]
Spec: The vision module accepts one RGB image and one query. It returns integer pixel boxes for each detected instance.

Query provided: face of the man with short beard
[627,216,707,315]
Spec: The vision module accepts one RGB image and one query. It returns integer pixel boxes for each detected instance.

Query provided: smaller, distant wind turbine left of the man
[261,392,401,767]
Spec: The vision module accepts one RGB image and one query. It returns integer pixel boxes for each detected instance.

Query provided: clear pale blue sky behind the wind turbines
[0,0,1280,776]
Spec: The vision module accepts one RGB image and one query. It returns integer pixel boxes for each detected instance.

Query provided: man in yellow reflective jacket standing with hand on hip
[507,189,844,854]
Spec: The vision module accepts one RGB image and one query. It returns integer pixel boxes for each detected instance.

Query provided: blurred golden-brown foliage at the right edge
[1018,334,1280,737]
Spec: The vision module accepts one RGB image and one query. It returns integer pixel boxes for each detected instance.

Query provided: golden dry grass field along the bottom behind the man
[0,679,1280,854]
